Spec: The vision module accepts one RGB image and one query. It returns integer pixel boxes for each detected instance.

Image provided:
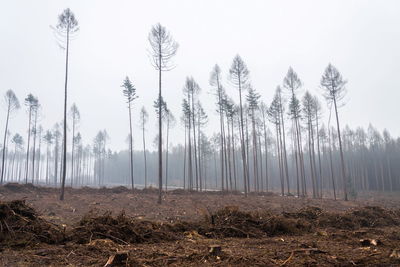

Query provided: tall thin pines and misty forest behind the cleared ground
[0,9,400,203]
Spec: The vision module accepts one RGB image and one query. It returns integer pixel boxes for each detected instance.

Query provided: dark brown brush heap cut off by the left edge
[0,200,63,247]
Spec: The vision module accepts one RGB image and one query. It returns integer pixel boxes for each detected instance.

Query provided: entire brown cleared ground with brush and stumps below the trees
[0,184,400,266]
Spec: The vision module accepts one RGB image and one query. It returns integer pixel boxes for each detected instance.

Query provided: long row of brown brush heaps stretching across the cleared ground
[0,200,400,252]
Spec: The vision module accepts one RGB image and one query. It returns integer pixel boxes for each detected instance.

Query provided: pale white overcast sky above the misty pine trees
[0,0,400,150]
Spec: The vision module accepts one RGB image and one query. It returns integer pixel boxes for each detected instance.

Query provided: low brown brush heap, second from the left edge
[68,212,178,244]
